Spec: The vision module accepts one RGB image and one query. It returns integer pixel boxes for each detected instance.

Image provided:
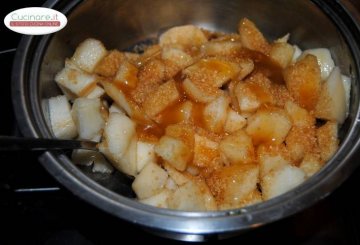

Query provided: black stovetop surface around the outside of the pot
[0,1,360,245]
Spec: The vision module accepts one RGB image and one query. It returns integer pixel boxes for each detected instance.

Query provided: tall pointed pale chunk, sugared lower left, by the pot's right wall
[315,67,346,124]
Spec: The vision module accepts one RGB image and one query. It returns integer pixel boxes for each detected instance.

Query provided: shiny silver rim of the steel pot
[12,0,360,234]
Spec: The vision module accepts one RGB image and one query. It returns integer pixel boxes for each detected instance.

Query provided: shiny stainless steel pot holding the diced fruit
[12,0,360,240]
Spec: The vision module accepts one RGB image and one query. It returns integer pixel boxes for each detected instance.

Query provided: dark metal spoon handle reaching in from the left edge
[0,136,98,151]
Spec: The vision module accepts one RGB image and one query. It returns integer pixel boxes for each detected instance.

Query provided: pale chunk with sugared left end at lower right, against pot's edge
[261,165,306,200]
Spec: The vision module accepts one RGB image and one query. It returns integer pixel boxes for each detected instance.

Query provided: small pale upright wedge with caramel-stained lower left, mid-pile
[203,96,230,133]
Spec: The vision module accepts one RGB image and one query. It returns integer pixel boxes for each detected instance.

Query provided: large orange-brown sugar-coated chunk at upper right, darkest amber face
[284,54,321,110]
